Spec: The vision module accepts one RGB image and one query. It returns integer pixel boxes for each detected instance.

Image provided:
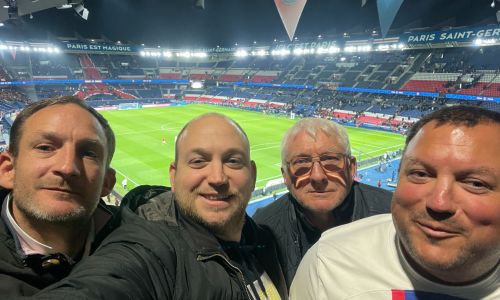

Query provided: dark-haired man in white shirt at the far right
[290,106,500,300]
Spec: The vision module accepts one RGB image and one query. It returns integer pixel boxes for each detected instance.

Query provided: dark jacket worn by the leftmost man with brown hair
[0,189,117,299]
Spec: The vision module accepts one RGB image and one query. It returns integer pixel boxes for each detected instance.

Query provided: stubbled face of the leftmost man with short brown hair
[0,104,115,222]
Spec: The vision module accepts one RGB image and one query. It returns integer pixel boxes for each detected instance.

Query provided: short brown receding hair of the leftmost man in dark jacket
[9,96,116,167]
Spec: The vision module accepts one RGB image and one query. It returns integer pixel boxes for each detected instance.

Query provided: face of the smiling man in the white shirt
[392,122,500,282]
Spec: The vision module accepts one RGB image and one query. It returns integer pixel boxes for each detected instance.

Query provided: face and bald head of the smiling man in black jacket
[170,116,256,236]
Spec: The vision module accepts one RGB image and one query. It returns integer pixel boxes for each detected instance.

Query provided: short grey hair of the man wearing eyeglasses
[281,118,351,166]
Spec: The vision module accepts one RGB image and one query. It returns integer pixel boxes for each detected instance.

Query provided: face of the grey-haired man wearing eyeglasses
[282,130,356,213]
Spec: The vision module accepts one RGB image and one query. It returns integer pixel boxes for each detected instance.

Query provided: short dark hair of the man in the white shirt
[405,105,500,149]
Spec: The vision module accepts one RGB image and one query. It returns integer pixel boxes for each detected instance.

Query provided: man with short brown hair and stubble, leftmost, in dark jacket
[0,97,115,297]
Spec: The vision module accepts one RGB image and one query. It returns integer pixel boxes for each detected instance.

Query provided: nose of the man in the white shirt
[425,178,455,218]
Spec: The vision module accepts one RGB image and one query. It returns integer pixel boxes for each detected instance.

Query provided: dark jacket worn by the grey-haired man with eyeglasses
[253,182,392,287]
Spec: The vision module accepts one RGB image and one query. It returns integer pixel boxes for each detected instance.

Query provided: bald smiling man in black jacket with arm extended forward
[31,113,287,300]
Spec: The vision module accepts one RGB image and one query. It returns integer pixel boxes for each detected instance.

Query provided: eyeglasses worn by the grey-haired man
[287,152,349,177]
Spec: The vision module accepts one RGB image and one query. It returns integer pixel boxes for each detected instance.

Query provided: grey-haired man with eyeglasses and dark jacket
[253,118,392,286]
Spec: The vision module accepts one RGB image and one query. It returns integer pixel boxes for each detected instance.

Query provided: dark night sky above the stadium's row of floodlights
[0,0,500,47]
